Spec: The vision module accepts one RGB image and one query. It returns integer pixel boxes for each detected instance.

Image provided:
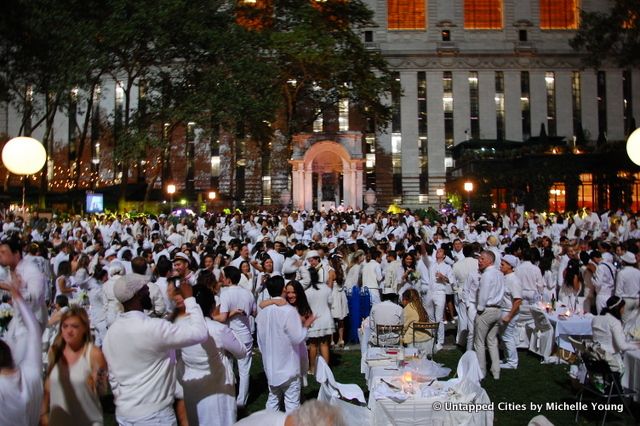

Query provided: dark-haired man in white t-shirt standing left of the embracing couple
[213,266,256,407]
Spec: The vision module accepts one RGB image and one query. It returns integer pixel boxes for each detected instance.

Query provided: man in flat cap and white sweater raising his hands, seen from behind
[103,270,208,425]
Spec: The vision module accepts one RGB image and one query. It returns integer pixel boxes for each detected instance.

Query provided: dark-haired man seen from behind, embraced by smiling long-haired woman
[256,276,315,413]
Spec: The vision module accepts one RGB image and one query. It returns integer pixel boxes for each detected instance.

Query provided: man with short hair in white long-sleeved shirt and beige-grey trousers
[473,250,504,380]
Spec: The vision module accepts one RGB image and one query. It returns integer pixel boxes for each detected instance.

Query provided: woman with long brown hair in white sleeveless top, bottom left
[40,306,107,425]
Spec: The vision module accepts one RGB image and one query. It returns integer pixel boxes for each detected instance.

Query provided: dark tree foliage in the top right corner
[570,0,640,69]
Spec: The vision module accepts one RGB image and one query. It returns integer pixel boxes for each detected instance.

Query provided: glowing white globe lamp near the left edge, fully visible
[2,136,47,175]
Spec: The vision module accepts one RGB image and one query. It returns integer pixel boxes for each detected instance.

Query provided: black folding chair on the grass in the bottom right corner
[576,352,637,426]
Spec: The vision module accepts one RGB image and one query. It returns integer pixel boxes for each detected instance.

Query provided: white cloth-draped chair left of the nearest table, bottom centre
[316,356,371,426]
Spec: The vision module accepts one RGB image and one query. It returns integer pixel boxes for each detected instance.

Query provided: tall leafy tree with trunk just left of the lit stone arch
[241,0,399,200]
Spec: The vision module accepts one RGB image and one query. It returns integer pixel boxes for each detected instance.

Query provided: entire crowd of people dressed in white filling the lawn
[0,205,640,425]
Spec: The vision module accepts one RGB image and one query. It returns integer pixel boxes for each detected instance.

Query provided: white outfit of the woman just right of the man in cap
[176,316,247,426]
